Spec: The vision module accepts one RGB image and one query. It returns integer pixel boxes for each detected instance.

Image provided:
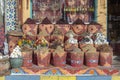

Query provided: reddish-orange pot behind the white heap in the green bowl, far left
[8,36,19,53]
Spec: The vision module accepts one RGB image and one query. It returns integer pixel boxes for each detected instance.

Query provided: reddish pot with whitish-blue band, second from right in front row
[85,53,99,67]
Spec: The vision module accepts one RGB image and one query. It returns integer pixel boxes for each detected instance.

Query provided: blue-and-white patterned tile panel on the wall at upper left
[5,0,16,31]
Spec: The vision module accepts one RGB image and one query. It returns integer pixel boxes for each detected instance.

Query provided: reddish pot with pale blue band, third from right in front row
[70,53,84,67]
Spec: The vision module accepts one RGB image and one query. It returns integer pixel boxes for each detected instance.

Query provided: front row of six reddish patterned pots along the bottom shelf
[20,51,112,67]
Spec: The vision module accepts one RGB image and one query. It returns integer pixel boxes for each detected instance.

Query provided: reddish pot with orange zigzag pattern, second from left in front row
[34,51,51,67]
